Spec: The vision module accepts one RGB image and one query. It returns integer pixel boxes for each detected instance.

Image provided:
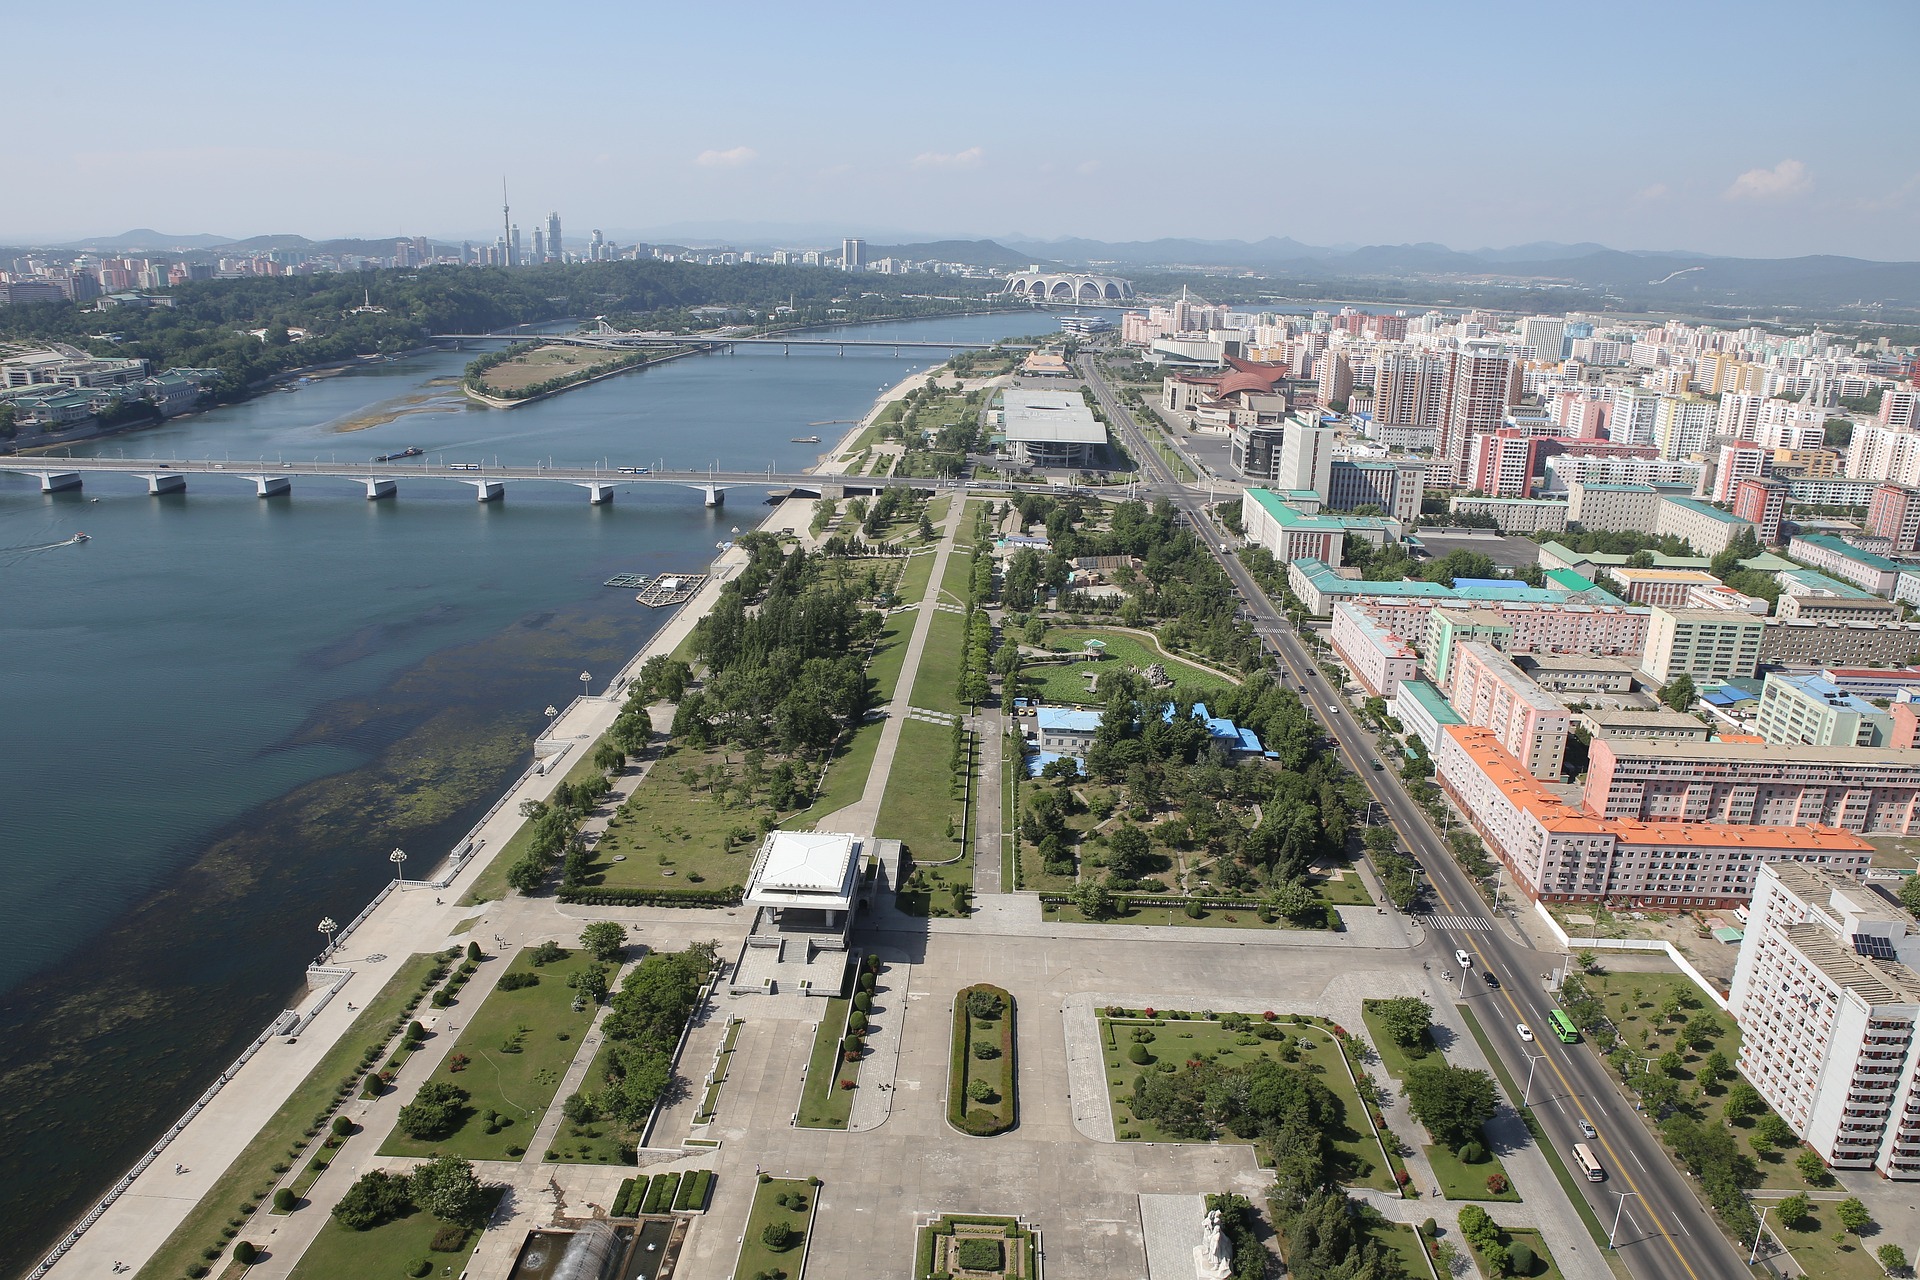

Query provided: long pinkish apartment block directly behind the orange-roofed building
[1584,741,1920,835]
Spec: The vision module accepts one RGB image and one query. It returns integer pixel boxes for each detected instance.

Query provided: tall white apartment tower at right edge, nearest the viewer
[1728,865,1920,1180]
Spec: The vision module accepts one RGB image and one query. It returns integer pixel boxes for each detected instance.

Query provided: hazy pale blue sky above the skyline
[15,0,1920,259]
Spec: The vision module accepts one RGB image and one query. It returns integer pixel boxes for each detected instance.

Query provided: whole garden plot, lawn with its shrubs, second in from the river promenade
[380,944,605,1159]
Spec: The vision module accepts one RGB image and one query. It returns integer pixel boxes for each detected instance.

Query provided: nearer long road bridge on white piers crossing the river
[0,455,1175,507]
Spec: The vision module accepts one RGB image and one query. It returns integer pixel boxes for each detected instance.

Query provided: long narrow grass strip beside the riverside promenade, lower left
[134,954,440,1280]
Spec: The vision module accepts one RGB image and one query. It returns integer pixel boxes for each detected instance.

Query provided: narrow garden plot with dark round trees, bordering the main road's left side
[1361,996,1521,1201]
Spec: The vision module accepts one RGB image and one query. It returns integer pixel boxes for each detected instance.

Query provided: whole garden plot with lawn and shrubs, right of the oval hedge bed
[1098,1009,1398,1192]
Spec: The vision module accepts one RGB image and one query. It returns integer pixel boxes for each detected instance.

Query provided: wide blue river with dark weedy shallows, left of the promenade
[0,313,1050,1274]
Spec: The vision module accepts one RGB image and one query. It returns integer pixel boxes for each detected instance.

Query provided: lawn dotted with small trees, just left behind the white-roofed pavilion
[582,747,768,889]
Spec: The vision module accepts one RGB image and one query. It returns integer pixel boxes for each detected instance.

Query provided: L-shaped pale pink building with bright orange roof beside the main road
[1434,725,1874,910]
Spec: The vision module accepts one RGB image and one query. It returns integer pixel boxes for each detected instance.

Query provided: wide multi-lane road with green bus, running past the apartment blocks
[1079,355,1751,1280]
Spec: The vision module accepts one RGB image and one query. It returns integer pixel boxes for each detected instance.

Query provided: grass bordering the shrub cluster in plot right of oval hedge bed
[1100,1017,1394,1192]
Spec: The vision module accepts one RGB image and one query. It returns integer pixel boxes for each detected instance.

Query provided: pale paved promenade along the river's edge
[38,347,952,1280]
